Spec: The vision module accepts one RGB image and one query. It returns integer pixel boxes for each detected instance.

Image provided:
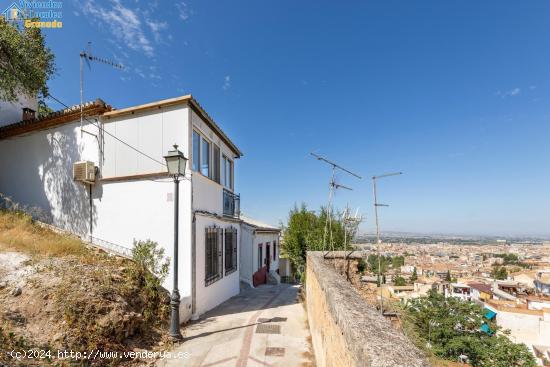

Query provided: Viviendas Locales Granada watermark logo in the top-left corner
[0,0,63,28]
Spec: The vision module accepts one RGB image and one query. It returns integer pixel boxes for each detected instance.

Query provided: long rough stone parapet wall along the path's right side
[306,251,430,367]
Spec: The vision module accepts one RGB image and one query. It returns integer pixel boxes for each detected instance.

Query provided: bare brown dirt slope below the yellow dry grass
[0,244,169,365]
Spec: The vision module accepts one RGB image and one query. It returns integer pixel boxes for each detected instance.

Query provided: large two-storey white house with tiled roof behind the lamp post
[0,95,250,321]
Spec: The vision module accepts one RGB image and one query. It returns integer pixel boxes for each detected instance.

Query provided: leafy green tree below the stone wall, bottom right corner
[405,290,536,367]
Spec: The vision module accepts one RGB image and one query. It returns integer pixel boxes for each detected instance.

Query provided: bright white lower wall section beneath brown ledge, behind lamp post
[93,180,192,320]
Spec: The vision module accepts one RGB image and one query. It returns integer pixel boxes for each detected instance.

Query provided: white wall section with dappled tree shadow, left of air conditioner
[0,118,98,235]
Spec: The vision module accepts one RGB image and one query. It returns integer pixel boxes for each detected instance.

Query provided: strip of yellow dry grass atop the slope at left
[0,210,89,257]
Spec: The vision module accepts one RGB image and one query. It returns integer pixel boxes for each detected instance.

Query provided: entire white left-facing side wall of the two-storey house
[0,107,192,320]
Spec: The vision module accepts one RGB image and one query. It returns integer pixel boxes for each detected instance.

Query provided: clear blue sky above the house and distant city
[37,0,550,235]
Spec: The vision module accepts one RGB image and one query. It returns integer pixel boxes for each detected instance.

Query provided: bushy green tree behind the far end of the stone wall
[281,204,351,277]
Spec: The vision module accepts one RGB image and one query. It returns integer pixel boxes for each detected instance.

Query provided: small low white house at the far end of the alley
[240,216,281,287]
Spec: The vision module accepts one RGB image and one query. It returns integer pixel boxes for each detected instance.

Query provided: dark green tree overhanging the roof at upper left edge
[0,17,55,102]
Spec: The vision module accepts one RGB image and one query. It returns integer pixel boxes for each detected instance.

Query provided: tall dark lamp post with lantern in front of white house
[164,144,187,340]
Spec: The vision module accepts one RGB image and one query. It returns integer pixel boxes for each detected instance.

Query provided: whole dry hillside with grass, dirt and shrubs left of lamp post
[0,211,169,366]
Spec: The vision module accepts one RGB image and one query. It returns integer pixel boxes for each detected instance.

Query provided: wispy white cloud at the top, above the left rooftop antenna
[82,0,154,56]
